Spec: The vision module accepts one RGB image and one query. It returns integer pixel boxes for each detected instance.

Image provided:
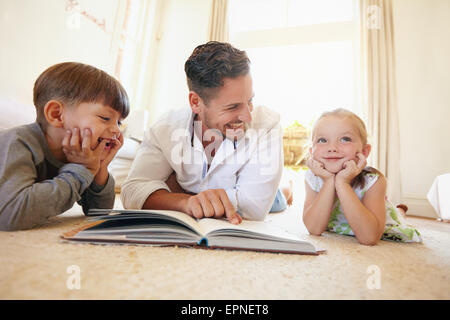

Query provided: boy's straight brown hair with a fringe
[33,62,130,129]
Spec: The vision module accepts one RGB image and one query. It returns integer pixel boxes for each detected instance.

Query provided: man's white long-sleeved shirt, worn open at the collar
[121,107,283,220]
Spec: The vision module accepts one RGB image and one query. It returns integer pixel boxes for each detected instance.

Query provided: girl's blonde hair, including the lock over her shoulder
[311,108,383,189]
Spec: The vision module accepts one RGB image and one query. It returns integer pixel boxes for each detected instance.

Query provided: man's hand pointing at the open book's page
[185,189,242,224]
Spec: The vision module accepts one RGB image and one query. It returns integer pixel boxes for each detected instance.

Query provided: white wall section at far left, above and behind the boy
[0,0,119,105]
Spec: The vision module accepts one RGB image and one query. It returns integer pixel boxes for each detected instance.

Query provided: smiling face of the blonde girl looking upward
[310,116,370,173]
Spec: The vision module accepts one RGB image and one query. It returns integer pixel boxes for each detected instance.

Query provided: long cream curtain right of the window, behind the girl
[360,0,401,203]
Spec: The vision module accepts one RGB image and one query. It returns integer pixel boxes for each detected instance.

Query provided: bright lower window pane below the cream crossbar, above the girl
[247,42,354,127]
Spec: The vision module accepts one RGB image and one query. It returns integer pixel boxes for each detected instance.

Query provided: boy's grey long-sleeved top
[0,122,115,231]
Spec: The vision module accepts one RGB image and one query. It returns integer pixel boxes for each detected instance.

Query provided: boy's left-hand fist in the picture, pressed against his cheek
[62,128,107,176]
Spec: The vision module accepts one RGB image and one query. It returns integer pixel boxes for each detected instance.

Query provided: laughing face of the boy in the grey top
[63,102,122,158]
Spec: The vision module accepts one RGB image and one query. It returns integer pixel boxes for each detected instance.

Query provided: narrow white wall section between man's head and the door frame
[148,0,211,122]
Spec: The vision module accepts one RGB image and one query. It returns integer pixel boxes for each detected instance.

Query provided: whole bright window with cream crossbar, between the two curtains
[229,0,359,127]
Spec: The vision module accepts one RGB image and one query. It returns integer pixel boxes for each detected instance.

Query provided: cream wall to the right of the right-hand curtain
[393,0,450,217]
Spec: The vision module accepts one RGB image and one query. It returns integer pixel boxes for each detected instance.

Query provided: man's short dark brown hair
[184,41,250,103]
